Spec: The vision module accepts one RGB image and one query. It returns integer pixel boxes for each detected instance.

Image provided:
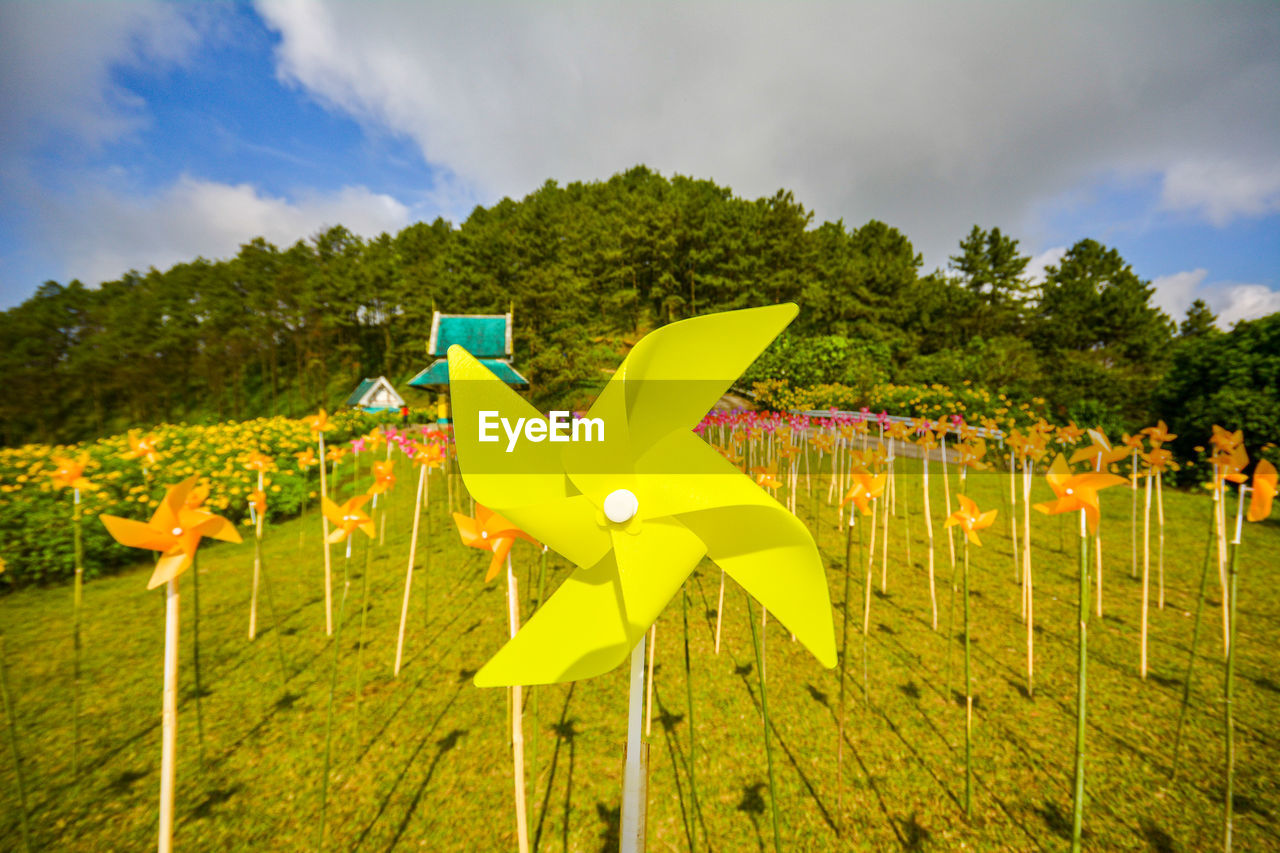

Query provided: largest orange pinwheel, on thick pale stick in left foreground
[99,476,241,589]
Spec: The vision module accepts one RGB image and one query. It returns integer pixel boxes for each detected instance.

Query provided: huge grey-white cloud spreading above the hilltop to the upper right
[259,0,1280,266]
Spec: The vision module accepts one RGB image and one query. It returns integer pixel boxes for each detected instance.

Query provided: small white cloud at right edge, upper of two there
[1160,160,1280,227]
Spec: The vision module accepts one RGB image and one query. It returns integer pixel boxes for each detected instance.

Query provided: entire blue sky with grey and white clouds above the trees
[0,0,1280,325]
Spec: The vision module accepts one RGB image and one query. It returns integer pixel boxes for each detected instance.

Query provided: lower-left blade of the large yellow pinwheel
[475,512,705,686]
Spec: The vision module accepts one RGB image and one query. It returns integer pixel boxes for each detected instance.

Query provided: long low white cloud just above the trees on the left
[40,177,410,284]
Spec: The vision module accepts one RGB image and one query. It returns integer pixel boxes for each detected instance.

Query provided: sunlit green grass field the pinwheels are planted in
[0,461,1280,850]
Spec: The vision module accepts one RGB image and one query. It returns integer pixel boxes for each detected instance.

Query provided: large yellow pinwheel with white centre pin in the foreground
[449,305,836,686]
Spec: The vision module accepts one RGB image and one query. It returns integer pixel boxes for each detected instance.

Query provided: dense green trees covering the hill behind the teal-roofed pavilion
[0,167,1269,444]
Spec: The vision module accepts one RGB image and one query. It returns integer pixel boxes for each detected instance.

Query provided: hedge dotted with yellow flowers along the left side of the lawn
[0,411,435,585]
